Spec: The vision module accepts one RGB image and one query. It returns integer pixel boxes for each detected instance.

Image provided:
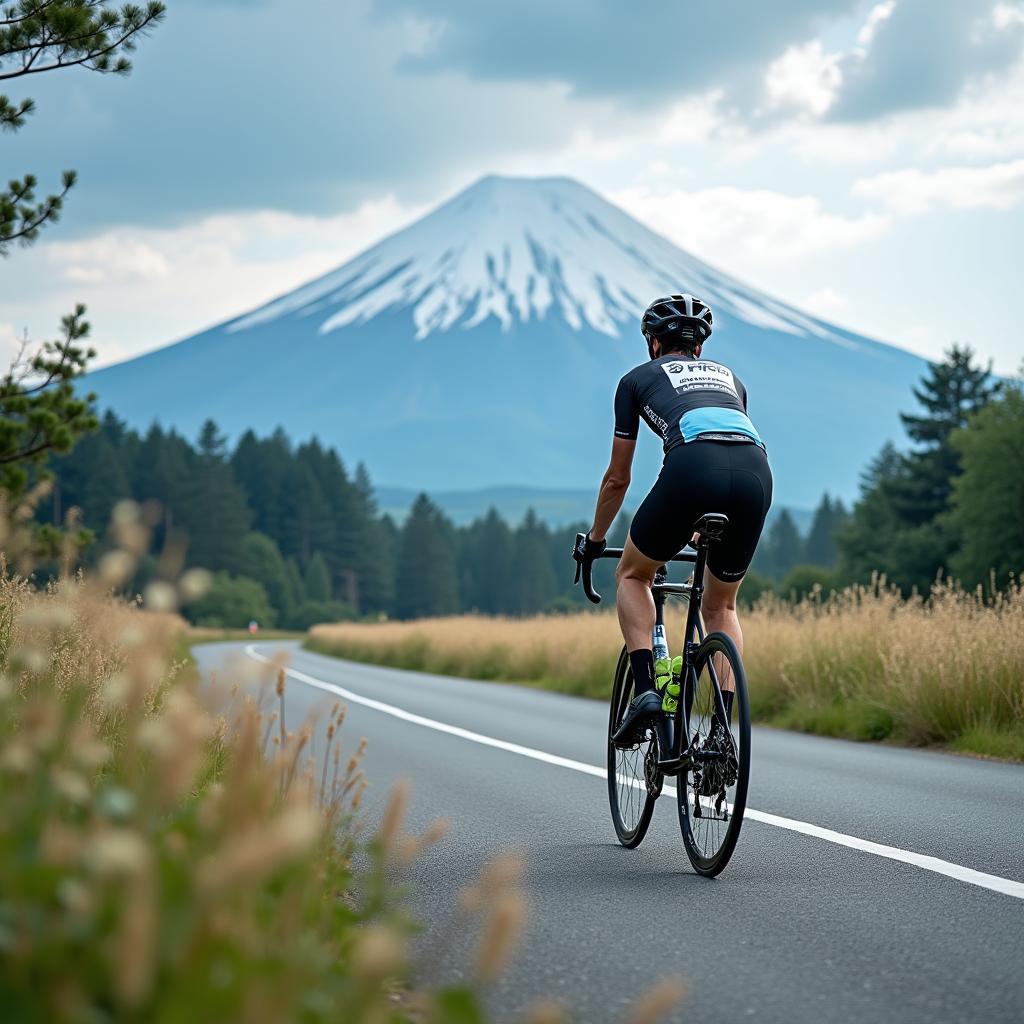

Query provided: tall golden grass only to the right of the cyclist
[744,581,1024,759]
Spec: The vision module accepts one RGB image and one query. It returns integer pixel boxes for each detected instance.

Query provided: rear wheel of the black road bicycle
[676,633,751,877]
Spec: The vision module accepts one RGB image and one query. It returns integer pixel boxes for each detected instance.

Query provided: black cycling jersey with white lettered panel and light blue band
[615,353,764,454]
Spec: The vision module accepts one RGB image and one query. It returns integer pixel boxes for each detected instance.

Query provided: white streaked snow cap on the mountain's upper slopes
[228,176,840,340]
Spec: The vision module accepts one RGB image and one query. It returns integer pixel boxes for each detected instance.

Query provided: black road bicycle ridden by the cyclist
[577,513,751,877]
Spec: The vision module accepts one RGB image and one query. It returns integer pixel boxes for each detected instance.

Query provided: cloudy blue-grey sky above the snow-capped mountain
[0,0,1024,373]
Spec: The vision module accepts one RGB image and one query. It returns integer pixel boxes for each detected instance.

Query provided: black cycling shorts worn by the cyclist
[630,440,772,583]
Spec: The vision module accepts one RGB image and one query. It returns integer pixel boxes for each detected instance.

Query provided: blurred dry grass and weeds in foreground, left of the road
[0,506,688,1024]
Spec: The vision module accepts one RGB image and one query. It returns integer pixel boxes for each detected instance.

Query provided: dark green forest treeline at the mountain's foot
[38,347,1024,628]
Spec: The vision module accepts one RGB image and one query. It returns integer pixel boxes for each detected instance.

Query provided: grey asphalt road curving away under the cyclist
[196,643,1024,1024]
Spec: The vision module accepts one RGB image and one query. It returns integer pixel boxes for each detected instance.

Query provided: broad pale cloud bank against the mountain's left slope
[6,197,421,365]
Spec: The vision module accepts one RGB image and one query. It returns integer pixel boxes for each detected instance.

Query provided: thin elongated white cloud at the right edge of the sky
[852,154,1024,214]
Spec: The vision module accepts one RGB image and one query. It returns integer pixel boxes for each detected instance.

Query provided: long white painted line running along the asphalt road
[246,644,1024,899]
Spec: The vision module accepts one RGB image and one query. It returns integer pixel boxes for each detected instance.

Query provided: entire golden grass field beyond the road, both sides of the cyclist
[307,584,1024,760]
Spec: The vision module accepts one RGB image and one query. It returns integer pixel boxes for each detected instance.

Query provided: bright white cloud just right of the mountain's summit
[610,186,888,276]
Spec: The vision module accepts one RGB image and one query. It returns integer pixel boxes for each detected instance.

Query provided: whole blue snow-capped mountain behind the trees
[90,177,924,505]
